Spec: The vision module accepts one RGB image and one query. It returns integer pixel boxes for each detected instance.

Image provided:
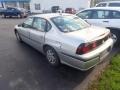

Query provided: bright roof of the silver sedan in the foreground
[30,13,72,19]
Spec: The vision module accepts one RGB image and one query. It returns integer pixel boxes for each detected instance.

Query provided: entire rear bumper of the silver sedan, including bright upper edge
[60,39,114,71]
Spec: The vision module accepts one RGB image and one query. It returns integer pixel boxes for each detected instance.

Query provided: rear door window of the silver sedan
[33,18,46,32]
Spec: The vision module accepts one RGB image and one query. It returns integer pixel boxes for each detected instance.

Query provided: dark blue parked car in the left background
[2,7,28,18]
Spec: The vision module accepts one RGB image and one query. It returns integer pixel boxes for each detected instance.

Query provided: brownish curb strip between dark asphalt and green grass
[73,48,120,90]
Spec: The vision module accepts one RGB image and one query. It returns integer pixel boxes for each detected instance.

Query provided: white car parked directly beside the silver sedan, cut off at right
[76,7,120,46]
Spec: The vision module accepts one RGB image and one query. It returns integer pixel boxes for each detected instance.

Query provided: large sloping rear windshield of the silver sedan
[51,16,90,32]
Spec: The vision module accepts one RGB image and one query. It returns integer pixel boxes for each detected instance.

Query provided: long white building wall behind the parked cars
[30,0,90,13]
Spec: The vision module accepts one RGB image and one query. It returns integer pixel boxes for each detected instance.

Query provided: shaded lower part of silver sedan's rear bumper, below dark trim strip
[62,48,110,71]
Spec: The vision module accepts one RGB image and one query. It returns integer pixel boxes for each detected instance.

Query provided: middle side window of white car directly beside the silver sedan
[92,10,110,19]
